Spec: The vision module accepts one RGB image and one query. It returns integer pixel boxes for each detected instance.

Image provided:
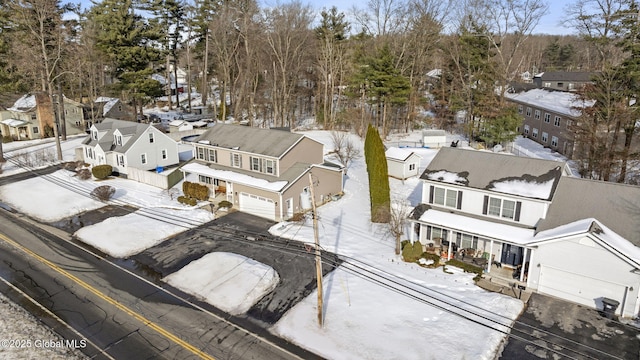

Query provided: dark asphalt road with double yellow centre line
[0,210,314,359]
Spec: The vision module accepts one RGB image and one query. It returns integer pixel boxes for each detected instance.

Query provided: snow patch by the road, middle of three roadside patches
[75,209,213,258]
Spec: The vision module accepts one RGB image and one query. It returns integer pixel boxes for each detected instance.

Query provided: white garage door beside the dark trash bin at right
[538,266,627,313]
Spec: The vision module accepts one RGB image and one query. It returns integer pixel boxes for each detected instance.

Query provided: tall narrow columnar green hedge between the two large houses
[364,124,391,223]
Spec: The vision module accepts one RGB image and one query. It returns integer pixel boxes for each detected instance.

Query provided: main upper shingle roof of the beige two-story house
[194,124,304,158]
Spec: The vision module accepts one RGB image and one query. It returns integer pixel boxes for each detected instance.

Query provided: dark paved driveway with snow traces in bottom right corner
[500,293,640,360]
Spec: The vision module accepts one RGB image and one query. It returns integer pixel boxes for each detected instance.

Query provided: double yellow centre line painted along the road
[0,234,215,360]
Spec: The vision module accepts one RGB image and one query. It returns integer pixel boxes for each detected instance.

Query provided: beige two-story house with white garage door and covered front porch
[181,124,343,221]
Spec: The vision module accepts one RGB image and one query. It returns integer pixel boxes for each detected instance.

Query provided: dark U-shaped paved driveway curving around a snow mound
[132,212,339,324]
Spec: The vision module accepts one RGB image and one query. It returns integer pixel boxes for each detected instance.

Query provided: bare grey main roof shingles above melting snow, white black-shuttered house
[420,147,566,201]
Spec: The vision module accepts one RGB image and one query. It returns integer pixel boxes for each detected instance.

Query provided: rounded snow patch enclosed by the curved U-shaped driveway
[162,252,280,315]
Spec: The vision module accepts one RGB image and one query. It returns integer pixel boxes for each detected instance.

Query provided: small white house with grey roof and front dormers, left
[81,119,179,174]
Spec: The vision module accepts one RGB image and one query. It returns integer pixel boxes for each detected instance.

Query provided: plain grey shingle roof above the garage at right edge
[537,177,640,246]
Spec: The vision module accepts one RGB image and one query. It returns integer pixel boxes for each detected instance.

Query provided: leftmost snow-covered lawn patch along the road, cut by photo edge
[0,173,106,222]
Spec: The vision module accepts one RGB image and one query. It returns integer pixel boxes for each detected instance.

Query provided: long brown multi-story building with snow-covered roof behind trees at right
[506,89,593,158]
